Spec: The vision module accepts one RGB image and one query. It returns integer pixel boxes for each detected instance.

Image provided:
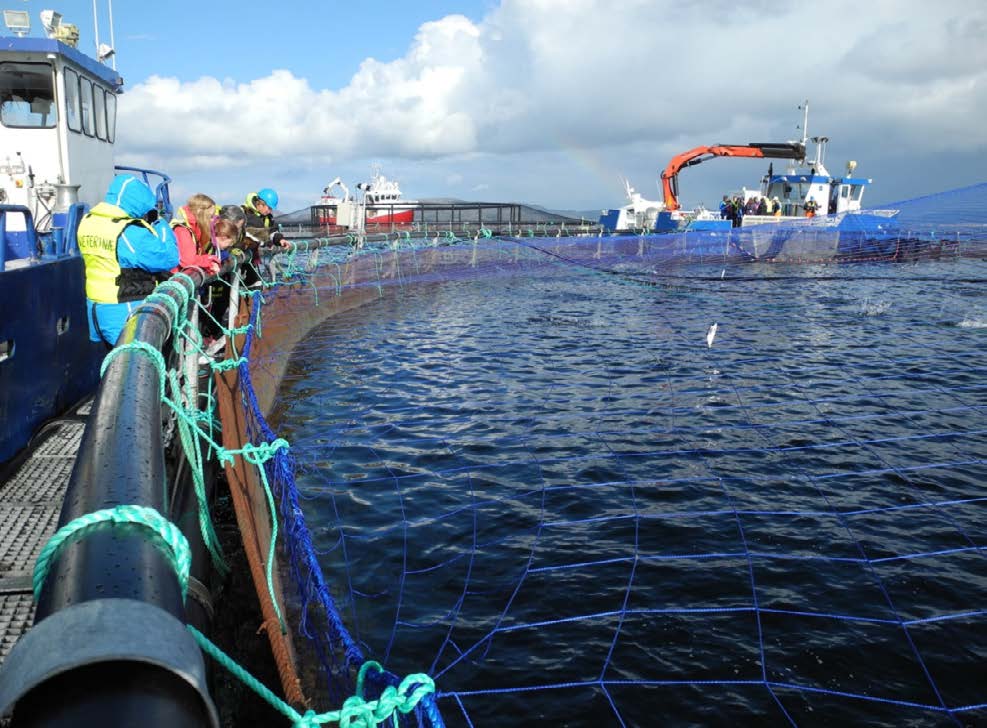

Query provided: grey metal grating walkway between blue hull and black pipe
[0,402,90,664]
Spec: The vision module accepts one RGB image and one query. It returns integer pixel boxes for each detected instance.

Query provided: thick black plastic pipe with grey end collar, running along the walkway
[0,266,220,727]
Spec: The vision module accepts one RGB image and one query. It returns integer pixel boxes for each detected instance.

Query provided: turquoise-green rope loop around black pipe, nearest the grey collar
[34,505,192,601]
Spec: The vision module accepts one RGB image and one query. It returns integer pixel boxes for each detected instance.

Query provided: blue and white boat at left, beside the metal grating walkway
[0,10,170,463]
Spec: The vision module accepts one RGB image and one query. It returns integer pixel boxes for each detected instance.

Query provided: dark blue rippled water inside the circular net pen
[272,260,987,726]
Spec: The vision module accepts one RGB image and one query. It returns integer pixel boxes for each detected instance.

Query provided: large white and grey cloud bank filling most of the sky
[119,0,987,208]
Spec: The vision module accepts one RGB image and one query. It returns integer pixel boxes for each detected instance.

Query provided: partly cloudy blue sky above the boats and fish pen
[4,0,987,212]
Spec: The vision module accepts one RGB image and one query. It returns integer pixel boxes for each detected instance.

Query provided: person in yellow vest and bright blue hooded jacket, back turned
[76,174,178,346]
